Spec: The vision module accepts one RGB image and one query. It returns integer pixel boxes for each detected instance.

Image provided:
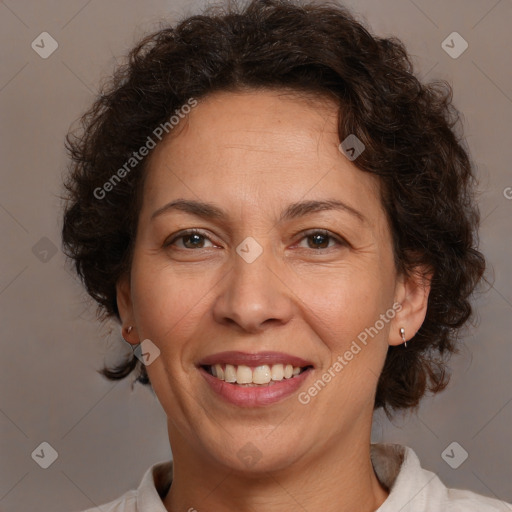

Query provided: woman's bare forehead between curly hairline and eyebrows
[140,90,381,226]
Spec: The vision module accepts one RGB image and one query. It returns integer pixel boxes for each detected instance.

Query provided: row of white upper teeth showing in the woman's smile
[201,364,313,387]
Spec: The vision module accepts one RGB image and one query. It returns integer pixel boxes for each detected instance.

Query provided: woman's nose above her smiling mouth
[213,242,294,333]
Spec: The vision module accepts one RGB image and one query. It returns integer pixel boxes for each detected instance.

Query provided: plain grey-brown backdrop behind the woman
[0,0,512,512]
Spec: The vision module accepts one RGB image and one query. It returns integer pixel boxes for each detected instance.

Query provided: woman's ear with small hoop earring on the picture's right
[389,266,433,345]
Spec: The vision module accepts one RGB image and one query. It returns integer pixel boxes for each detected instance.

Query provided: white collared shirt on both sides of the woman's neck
[77,443,512,512]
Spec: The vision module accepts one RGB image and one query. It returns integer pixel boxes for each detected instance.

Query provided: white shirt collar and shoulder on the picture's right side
[371,443,512,512]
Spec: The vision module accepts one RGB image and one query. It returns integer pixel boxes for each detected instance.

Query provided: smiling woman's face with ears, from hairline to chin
[118,91,426,469]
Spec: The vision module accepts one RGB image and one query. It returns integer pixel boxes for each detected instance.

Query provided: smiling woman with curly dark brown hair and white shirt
[63,0,507,512]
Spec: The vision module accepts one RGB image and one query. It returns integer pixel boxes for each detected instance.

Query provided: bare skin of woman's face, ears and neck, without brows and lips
[117,90,429,512]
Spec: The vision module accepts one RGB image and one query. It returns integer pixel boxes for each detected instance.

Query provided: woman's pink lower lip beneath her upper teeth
[199,368,311,407]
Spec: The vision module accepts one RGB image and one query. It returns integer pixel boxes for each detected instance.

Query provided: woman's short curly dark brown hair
[62,0,485,416]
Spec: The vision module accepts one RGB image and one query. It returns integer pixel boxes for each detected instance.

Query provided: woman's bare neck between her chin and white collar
[164,424,389,512]
